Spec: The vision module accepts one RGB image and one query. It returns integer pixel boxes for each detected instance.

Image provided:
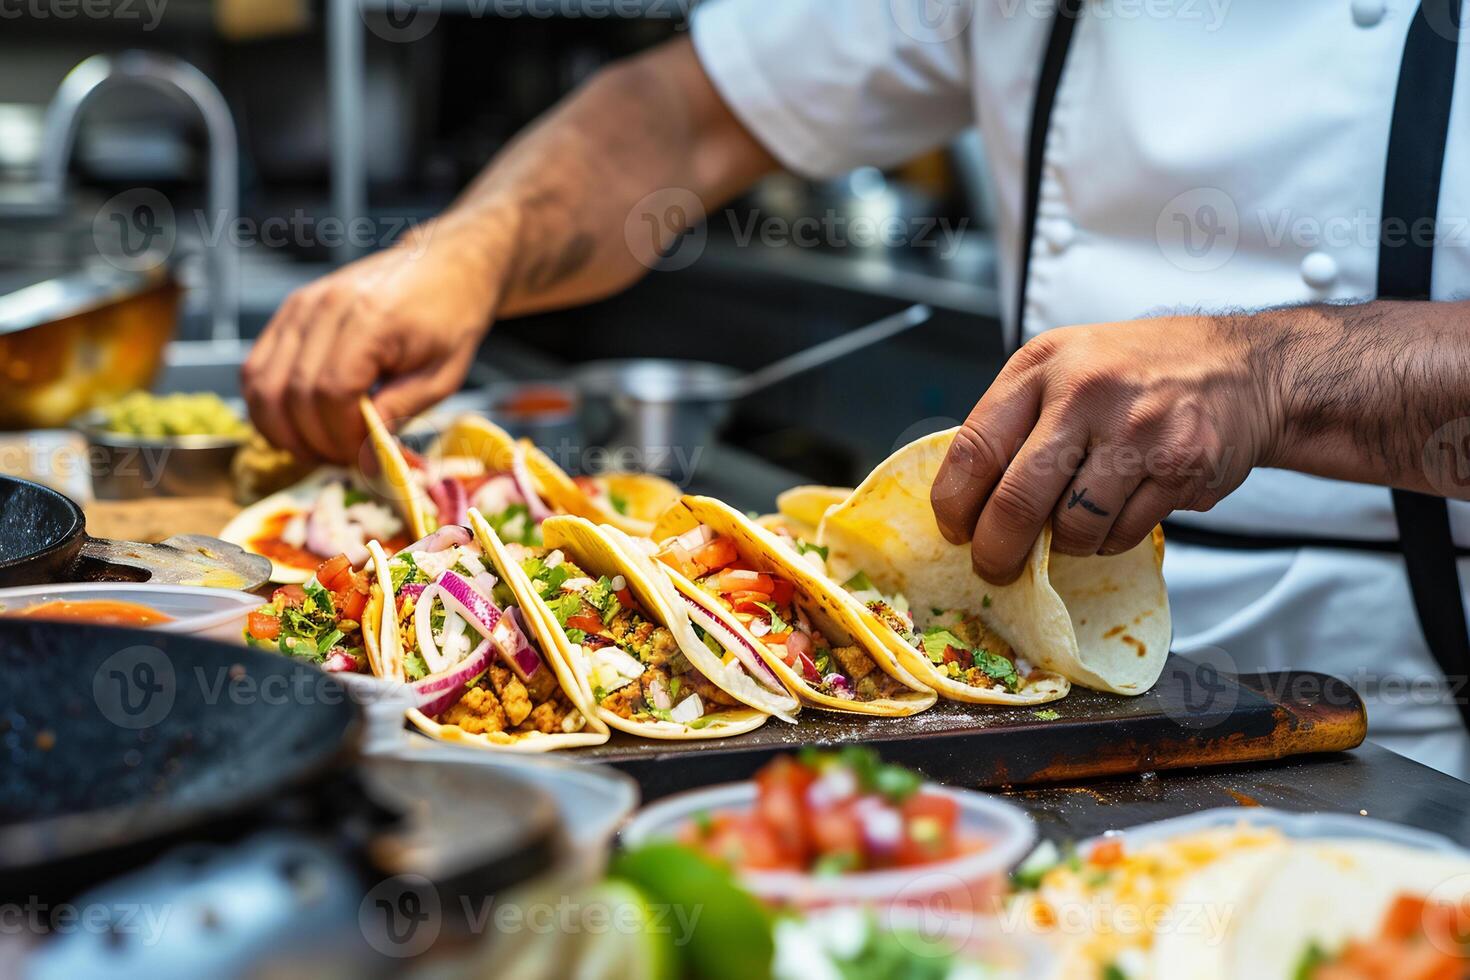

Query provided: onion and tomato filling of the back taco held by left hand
[400,445,554,545]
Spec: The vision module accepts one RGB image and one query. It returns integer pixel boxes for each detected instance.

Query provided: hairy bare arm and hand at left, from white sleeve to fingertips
[244,38,776,461]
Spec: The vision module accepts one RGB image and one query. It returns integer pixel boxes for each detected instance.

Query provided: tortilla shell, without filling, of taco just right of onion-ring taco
[490,508,770,741]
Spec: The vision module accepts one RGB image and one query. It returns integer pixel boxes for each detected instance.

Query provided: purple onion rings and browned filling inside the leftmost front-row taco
[388,525,587,735]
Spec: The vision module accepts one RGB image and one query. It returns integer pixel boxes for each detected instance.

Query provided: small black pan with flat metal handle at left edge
[0,476,270,591]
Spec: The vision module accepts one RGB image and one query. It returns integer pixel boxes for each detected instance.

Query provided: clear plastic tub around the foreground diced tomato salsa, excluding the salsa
[620,782,1036,917]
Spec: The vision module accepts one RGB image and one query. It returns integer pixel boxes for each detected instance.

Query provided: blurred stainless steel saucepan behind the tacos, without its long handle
[572,359,741,473]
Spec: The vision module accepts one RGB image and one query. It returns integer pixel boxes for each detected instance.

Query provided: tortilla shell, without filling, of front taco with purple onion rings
[363,520,612,752]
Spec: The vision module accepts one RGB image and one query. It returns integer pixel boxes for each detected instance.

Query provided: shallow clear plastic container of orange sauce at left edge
[0,582,265,644]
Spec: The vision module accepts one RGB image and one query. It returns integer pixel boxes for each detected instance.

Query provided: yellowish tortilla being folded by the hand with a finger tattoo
[817,429,1172,695]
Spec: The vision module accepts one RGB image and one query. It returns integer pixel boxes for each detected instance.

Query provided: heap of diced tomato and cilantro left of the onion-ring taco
[245,555,372,673]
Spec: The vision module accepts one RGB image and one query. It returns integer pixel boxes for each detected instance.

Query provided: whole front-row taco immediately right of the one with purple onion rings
[485,513,800,739]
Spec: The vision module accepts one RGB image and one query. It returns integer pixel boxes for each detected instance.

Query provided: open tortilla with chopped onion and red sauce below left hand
[219,467,415,585]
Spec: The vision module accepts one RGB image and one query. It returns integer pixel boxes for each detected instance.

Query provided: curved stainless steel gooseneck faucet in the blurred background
[38,51,240,341]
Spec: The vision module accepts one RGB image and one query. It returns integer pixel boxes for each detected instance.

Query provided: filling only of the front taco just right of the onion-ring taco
[512,548,745,729]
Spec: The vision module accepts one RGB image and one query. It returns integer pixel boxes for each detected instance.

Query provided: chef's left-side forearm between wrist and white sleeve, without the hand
[428,38,775,316]
